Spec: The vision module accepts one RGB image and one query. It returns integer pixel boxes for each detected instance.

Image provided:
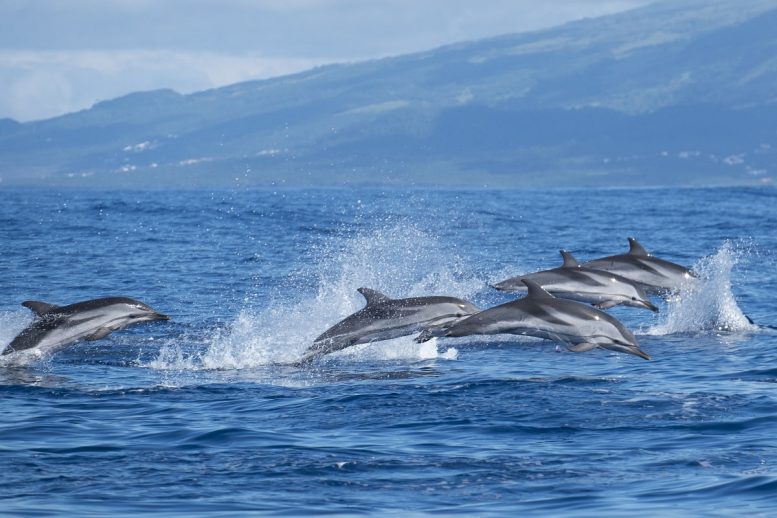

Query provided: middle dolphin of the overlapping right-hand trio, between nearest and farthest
[494,250,658,312]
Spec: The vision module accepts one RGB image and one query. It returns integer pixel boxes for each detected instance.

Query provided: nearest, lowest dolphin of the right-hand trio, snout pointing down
[416,279,650,360]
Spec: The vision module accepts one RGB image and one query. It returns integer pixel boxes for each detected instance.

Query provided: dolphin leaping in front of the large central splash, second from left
[297,288,480,364]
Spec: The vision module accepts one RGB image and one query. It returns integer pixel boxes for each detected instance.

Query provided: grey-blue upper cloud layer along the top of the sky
[0,0,648,55]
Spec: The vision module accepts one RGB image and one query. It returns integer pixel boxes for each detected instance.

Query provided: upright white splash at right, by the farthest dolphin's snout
[648,241,757,335]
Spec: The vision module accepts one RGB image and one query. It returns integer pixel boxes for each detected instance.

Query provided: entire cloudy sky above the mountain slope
[0,0,650,122]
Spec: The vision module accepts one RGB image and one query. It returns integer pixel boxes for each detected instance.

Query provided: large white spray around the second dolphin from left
[147,224,483,370]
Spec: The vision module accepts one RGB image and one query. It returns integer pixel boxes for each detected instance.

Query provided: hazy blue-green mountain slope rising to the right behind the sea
[0,0,777,187]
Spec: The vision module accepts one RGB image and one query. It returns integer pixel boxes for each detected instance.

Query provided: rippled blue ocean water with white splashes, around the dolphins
[0,188,777,516]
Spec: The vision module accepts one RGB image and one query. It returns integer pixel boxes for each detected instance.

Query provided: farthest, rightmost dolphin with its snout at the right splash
[583,237,695,293]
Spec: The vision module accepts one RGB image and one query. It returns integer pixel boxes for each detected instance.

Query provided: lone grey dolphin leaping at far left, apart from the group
[3,297,170,355]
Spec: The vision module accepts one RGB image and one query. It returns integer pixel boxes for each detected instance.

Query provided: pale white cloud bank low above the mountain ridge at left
[0,50,330,121]
